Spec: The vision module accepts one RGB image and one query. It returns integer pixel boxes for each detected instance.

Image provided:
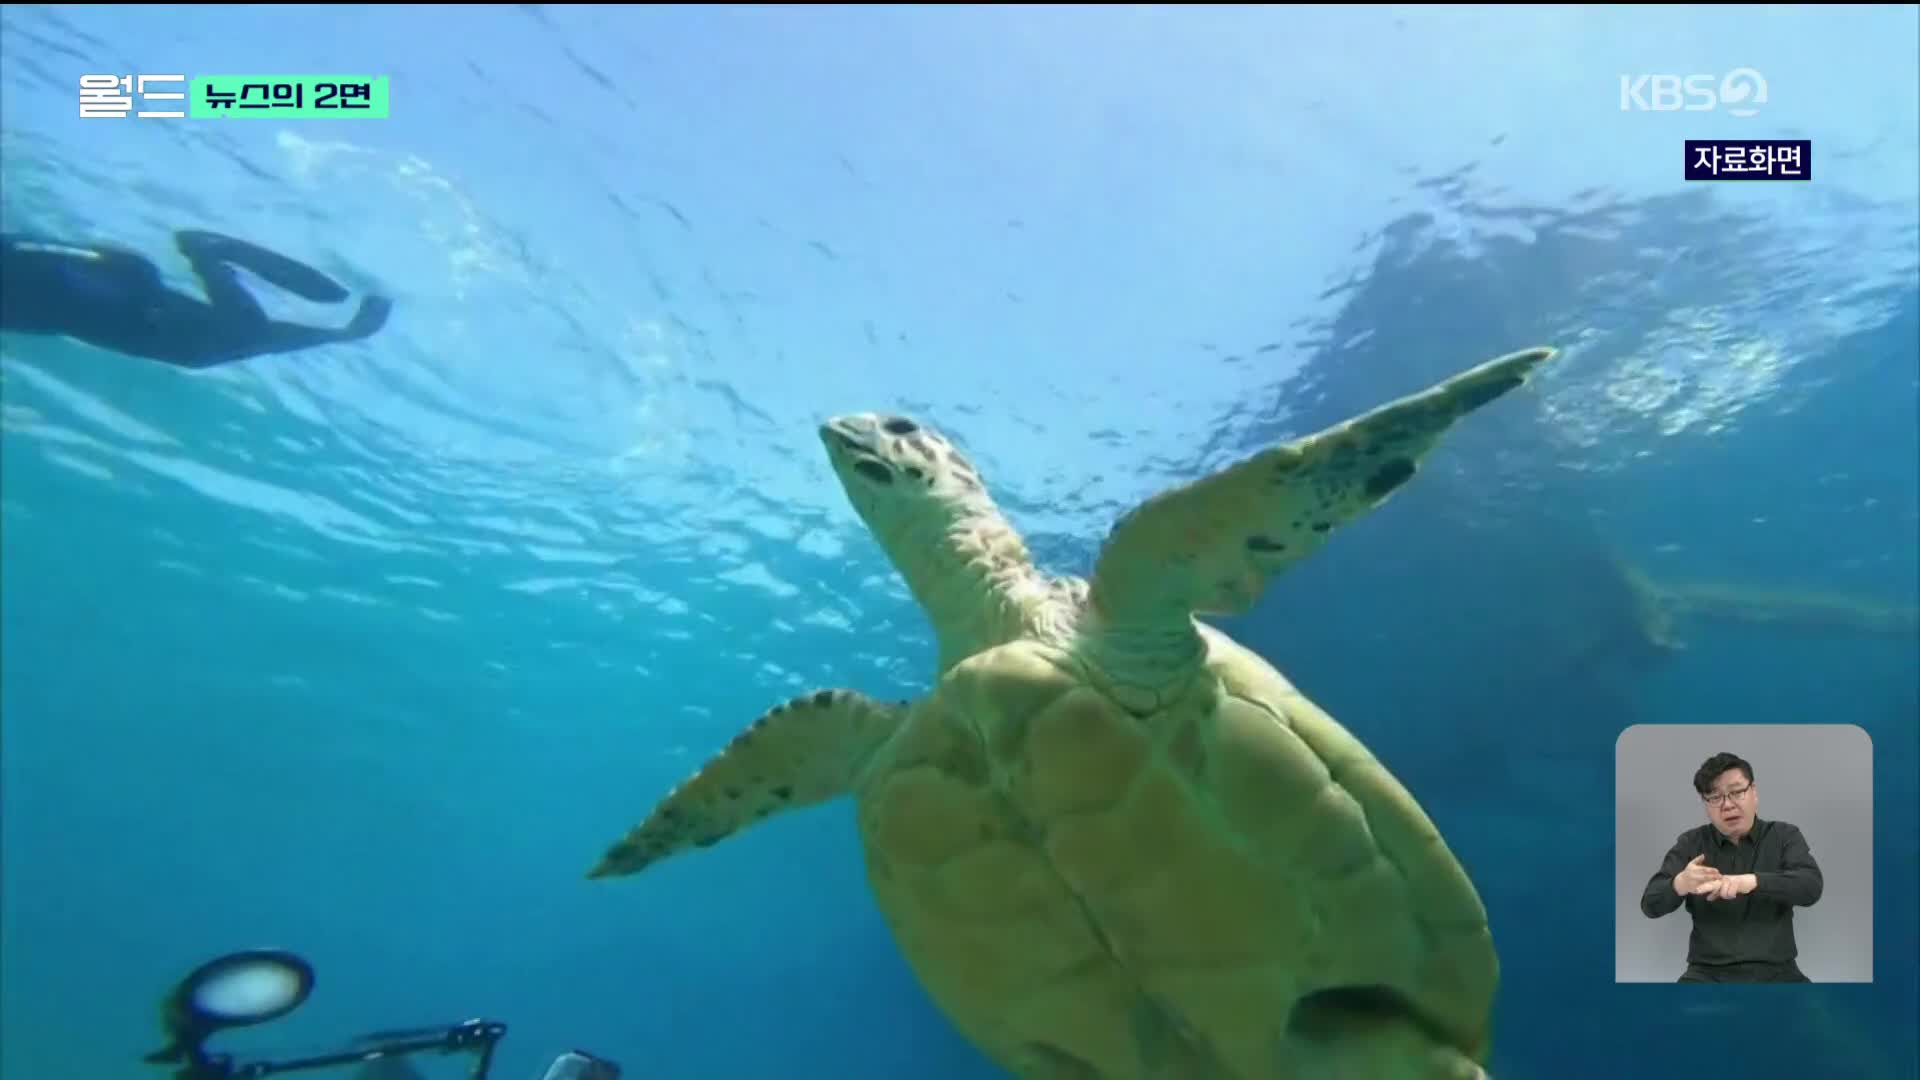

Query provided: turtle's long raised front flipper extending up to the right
[1092,348,1555,636]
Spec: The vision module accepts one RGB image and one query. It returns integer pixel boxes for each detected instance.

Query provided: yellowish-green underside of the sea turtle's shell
[856,625,1498,1080]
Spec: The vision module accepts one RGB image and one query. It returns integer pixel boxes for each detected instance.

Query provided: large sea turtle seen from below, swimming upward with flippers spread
[588,348,1555,1080]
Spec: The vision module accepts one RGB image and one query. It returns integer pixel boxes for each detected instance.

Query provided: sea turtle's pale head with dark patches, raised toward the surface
[820,413,998,548]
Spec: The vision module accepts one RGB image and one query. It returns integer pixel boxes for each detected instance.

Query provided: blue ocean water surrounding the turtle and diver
[0,6,1920,1080]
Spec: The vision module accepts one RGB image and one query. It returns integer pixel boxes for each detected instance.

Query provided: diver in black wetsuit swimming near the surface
[0,229,394,369]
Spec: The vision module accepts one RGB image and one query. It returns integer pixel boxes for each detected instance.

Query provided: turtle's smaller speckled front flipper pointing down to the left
[588,690,906,878]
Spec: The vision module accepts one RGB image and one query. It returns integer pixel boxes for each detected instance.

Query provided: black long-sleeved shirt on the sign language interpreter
[1640,819,1824,967]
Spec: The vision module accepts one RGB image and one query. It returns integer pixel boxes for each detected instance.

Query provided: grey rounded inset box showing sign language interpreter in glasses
[1613,724,1874,982]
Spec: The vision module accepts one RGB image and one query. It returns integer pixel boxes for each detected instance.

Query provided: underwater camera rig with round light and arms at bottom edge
[144,949,620,1080]
